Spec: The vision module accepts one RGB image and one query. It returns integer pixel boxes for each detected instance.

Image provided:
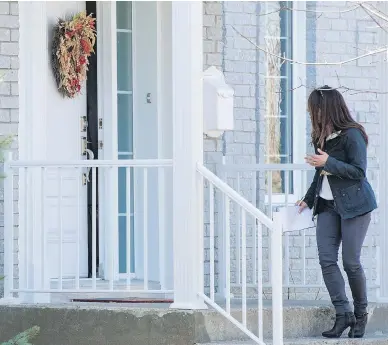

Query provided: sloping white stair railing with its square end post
[197,165,283,345]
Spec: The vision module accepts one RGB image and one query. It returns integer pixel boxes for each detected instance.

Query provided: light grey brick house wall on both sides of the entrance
[0,1,381,299]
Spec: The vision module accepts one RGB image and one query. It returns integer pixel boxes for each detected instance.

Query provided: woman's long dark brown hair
[308,85,368,148]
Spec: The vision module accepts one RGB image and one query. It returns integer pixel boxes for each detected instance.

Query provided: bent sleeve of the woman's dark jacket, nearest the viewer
[323,128,367,180]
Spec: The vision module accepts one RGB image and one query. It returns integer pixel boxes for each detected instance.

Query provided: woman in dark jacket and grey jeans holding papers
[299,85,377,338]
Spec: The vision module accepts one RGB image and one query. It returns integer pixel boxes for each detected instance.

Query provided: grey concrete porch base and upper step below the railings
[0,301,388,345]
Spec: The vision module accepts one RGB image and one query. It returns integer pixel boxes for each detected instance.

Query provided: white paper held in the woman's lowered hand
[279,206,315,231]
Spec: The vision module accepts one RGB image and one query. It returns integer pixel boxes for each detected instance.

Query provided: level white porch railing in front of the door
[4,156,173,300]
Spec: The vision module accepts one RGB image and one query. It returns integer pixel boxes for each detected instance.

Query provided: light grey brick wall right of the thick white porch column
[204,1,379,299]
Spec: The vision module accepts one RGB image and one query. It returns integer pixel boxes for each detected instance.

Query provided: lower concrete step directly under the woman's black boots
[200,335,388,345]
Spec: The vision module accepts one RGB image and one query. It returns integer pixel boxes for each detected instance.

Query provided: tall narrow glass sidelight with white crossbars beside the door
[116,1,135,274]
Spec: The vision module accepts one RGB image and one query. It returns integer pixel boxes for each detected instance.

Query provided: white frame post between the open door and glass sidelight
[96,1,118,280]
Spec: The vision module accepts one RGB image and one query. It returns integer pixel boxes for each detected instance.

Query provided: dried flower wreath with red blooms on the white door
[51,12,96,98]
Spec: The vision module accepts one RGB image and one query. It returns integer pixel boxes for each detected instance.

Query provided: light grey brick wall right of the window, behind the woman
[300,1,379,298]
